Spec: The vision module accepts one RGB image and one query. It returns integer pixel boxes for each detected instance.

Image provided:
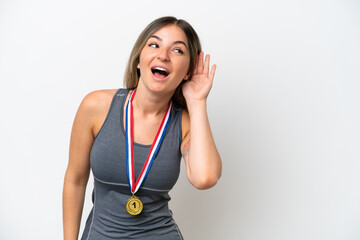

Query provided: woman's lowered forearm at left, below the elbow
[63,178,86,240]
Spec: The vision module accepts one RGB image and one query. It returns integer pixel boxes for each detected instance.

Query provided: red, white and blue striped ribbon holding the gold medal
[125,89,172,195]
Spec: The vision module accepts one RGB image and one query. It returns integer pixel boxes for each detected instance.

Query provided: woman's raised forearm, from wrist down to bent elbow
[187,100,222,189]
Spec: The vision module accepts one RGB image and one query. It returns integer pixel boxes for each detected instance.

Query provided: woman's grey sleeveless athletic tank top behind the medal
[81,89,183,240]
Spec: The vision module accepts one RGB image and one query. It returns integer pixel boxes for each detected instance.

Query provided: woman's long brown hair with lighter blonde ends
[124,16,201,109]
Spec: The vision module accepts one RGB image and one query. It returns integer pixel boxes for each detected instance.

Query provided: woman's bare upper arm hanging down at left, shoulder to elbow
[66,91,113,185]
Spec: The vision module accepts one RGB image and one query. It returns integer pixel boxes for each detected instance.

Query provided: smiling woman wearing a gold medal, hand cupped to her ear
[63,17,221,240]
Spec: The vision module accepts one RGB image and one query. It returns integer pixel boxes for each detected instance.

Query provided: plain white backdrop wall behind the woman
[0,0,360,240]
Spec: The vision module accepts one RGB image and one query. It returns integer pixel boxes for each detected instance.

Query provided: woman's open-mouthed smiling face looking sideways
[138,25,190,92]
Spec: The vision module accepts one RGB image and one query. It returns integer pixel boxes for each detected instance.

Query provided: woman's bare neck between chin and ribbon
[133,84,172,115]
